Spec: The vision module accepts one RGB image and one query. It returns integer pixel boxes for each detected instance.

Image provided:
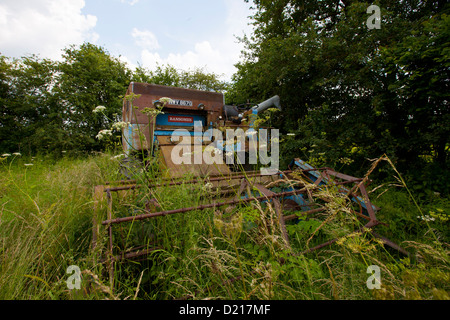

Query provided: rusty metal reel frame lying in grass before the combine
[93,159,408,288]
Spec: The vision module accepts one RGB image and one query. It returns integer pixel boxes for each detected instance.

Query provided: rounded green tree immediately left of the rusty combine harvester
[57,43,131,150]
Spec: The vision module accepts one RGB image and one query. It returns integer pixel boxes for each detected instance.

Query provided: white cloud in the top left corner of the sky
[0,0,99,59]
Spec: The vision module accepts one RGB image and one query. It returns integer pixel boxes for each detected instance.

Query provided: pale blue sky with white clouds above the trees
[0,0,252,80]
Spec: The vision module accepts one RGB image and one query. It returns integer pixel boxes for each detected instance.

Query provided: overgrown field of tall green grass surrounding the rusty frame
[0,154,450,300]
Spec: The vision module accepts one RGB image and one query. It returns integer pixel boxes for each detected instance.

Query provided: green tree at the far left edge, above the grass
[0,55,63,152]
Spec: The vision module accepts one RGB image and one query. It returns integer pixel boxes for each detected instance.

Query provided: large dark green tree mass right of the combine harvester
[228,0,449,180]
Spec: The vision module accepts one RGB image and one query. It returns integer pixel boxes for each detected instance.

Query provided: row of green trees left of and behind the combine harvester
[0,43,227,154]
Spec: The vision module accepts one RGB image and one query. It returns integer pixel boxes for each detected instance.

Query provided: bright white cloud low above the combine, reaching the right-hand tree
[135,0,251,80]
